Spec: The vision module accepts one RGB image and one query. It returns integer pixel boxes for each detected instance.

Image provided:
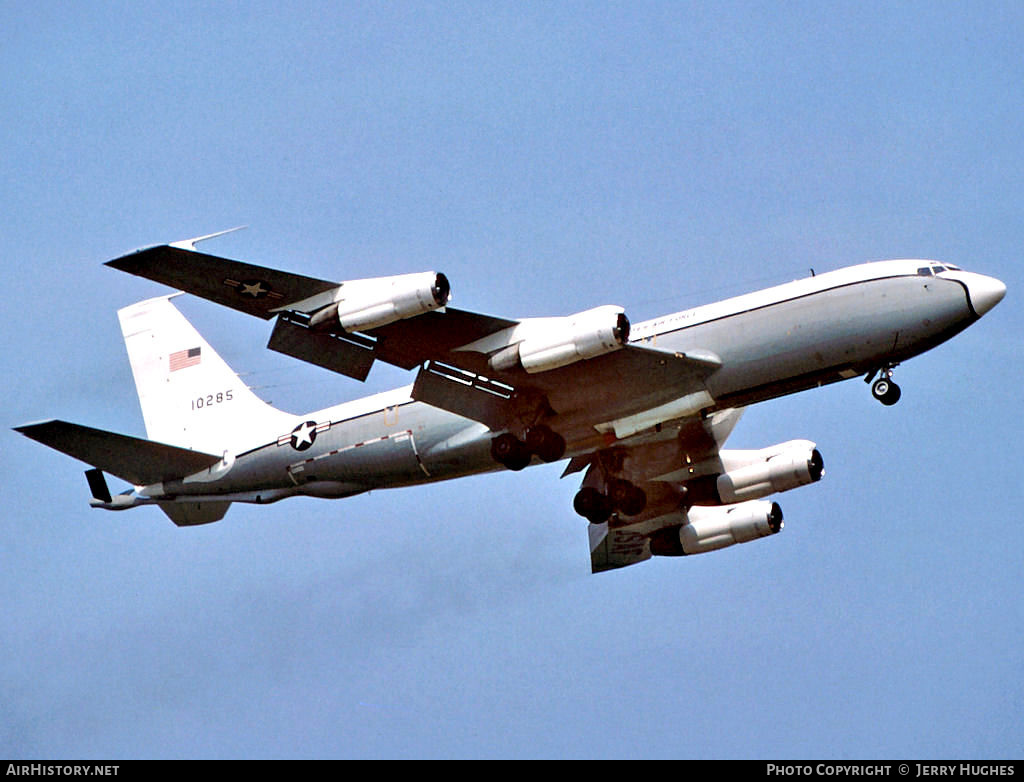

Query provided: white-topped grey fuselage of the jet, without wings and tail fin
[139,261,1005,503]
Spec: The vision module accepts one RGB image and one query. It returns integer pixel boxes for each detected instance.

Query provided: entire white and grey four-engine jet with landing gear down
[17,234,1006,572]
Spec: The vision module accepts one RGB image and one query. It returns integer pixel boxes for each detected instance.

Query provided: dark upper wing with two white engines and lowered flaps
[108,240,721,439]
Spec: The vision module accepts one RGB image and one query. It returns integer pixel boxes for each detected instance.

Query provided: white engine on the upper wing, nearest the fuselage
[489,305,630,374]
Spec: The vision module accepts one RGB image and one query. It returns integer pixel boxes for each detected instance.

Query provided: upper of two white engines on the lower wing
[686,440,824,505]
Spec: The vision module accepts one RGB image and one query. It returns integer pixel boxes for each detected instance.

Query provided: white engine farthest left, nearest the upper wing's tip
[309,271,452,332]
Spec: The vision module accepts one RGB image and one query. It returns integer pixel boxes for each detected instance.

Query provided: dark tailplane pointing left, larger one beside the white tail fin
[14,421,221,486]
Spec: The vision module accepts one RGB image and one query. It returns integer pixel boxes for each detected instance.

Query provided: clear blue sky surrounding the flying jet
[0,2,1024,758]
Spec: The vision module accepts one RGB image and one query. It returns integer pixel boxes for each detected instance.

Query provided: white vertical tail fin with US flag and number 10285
[118,294,294,453]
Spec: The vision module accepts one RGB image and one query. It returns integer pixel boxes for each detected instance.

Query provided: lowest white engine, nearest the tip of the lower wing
[650,501,783,557]
